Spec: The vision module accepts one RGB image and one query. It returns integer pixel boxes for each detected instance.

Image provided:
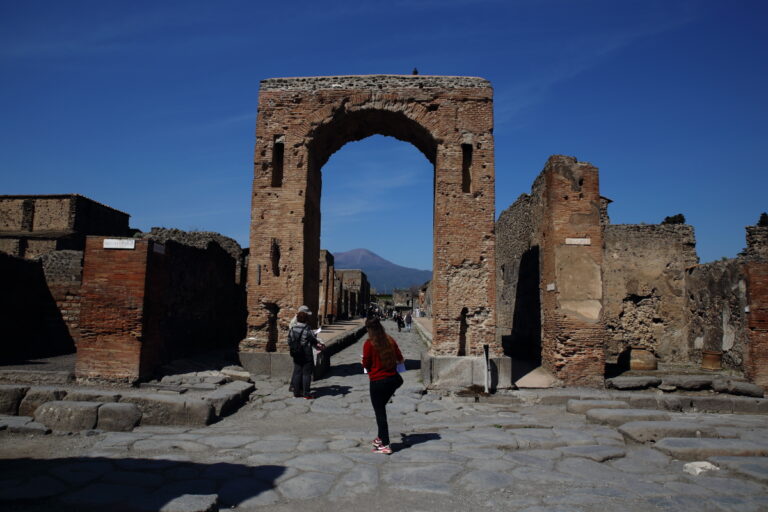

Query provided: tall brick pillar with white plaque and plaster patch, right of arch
[541,155,606,386]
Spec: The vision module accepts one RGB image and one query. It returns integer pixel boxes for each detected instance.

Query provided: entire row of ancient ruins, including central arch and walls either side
[0,75,768,388]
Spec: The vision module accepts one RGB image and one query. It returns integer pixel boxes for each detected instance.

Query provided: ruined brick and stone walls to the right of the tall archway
[496,156,768,386]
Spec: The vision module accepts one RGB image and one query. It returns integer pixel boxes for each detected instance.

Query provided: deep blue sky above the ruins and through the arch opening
[0,0,768,268]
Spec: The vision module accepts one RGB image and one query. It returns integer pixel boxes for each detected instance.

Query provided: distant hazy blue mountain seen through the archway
[333,249,432,293]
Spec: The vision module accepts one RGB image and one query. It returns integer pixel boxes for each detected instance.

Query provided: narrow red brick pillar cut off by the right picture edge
[744,262,768,388]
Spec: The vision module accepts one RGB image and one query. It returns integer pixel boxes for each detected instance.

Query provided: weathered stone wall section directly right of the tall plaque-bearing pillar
[603,224,698,363]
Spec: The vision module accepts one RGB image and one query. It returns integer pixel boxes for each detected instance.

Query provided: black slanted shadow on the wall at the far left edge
[0,253,75,362]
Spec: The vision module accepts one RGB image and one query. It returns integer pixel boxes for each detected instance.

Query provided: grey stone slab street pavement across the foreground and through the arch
[0,322,768,512]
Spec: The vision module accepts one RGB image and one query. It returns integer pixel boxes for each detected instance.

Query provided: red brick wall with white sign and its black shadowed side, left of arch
[77,237,245,381]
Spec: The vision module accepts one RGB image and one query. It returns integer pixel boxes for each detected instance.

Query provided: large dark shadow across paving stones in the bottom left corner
[0,457,286,512]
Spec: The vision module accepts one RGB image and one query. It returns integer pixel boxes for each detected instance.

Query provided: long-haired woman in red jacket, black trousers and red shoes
[363,318,404,455]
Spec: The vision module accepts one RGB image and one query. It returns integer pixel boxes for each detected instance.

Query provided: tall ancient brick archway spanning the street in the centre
[240,75,501,368]
